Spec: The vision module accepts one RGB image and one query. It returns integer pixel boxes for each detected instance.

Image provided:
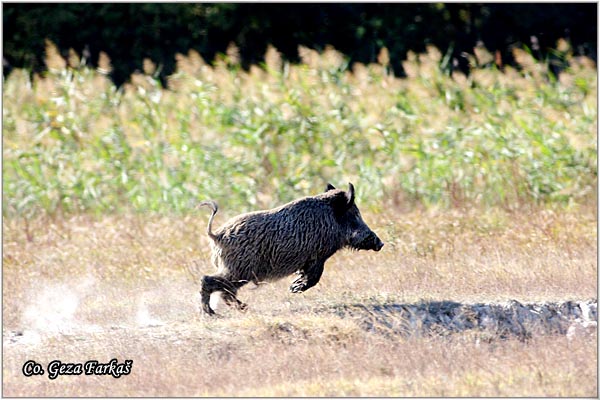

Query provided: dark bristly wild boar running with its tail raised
[198,183,383,314]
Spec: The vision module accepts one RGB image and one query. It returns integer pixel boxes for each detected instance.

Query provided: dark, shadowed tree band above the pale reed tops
[3,3,597,85]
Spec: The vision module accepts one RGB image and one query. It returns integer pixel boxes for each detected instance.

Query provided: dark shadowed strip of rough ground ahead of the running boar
[329,299,598,339]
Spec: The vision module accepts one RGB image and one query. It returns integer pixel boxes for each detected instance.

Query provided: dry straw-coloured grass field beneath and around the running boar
[3,206,598,397]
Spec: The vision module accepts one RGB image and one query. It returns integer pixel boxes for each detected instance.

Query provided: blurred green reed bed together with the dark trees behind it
[3,4,597,216]
